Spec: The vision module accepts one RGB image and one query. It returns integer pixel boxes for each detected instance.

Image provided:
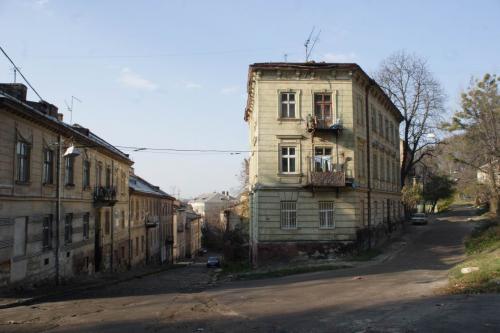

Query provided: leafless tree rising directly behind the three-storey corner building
[374,51,446,184]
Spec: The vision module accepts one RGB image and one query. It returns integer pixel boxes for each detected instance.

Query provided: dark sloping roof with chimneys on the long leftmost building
[0,85,134,165]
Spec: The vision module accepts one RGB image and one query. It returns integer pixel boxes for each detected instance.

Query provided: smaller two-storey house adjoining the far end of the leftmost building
[129,174,175,266]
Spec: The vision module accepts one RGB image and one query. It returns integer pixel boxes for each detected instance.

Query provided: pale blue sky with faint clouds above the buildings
[0,0,500,197]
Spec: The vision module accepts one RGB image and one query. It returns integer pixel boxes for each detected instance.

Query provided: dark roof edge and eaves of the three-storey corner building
[244,61,403,122]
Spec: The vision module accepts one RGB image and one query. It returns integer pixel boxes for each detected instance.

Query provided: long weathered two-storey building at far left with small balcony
[0,84,133,285]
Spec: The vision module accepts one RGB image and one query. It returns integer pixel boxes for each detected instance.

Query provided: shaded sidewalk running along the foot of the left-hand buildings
[0,261,193,309]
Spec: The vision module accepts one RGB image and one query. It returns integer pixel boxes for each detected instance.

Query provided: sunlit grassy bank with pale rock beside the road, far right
[448,221,500,294]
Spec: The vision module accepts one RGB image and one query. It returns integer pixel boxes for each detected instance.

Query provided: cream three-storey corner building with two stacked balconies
[244,62,402,264]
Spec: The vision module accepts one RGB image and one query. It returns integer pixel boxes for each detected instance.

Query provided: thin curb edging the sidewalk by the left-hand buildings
[0,263,192,310]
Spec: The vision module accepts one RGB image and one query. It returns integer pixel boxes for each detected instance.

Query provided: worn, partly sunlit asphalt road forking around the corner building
[0,207,500,332]
